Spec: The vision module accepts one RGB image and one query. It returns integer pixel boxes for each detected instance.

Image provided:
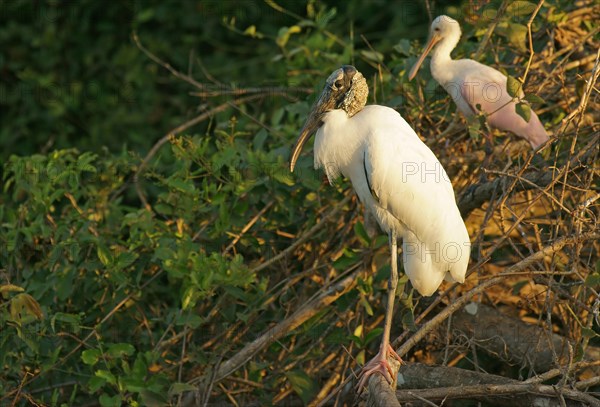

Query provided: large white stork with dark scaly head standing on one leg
[290,65,470,391]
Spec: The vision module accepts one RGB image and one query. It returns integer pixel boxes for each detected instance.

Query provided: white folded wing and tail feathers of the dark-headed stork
[364,110,470,295]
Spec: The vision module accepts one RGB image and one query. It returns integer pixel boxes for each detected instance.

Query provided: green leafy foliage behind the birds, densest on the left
[0,0,600,406]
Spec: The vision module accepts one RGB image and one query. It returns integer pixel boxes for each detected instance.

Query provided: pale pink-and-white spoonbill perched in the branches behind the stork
[408,15,548,149]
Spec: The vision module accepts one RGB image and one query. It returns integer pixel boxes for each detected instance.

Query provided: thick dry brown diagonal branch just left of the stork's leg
[183,267,362,406]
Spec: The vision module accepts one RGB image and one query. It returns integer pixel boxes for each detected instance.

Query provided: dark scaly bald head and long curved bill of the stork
[290,65,369,171]
